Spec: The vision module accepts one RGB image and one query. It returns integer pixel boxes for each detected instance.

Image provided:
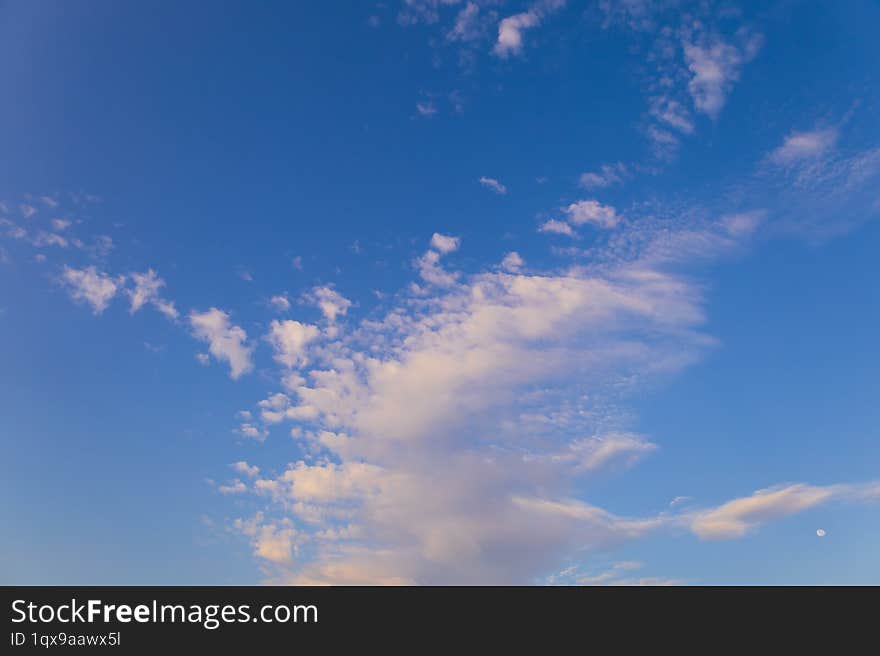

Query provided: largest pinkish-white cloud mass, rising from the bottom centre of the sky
[232,247,716,583]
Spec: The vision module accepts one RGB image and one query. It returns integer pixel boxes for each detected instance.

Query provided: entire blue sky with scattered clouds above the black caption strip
[0,0,880,584]
